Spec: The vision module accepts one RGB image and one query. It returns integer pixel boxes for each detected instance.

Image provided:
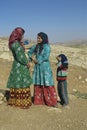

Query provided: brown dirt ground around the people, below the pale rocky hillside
[0,59,87,130]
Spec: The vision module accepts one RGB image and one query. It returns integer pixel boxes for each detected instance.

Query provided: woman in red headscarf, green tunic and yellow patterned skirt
[7,27,32,108]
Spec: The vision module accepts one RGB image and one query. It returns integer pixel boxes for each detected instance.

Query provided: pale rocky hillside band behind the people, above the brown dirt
[0,39,87,68]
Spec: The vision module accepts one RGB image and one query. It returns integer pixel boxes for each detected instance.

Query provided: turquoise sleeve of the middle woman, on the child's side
[37,45,50,64]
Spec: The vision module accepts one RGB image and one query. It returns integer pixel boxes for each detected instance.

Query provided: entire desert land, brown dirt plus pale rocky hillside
[0,39,87,130]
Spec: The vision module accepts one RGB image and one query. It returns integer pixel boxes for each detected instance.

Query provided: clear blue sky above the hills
[0,0,87,42]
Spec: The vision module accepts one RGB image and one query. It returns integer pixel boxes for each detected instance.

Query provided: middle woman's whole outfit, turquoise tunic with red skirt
[28,44,57,106]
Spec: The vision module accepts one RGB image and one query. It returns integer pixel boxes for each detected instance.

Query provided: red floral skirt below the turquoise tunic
[34,85,57,106]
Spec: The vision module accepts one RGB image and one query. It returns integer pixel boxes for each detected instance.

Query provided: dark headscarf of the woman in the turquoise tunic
[34,32,48,54]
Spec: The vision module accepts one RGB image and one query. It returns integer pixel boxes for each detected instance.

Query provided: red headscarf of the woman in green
[9,27,25,48]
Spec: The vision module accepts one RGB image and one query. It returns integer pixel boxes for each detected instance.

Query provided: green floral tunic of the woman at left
[7,42,32,88]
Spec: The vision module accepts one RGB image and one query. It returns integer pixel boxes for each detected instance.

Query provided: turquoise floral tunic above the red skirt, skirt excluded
[28,44,54,86]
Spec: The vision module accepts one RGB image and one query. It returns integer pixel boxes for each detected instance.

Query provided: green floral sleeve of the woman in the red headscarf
[12,42,28,65]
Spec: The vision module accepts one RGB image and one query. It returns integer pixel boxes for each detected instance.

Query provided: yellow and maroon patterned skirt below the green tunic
[8,88,32,109]
